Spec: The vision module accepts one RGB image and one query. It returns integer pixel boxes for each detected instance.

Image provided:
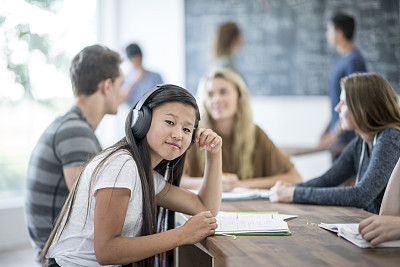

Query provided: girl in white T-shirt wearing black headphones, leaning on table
[41,85,222,266]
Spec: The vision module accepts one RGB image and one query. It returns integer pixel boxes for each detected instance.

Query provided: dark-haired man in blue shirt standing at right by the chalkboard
[318,14,366,159]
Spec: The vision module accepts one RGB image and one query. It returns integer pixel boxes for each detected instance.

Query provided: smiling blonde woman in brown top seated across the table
[181,69,301,191]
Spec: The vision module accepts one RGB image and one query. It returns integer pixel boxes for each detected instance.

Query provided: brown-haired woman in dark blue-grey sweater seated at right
[270,73,400,213]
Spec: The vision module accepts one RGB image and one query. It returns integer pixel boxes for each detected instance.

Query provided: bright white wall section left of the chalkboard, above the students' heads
[98,0,185,84]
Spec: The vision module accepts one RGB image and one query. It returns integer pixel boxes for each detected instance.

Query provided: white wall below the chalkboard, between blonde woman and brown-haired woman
[252,96,332,181]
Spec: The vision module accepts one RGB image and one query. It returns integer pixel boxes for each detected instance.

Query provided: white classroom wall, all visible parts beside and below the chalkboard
[0,0,330,253]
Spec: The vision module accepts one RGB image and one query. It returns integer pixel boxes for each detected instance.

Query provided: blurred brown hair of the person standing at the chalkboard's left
[212,22,240,59]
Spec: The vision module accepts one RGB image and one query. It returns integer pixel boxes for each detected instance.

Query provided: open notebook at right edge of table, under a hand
[318,223,400,248]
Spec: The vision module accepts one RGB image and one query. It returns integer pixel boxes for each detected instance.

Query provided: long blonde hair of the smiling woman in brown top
[195,68,256,180]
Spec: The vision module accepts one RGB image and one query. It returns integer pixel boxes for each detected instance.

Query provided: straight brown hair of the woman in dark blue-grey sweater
[340,73,400,135]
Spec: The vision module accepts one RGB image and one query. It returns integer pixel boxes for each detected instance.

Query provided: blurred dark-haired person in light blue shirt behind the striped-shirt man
[123,44,163,108]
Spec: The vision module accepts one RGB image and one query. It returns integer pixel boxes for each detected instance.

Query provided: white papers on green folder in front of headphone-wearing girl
[215,211,296,235]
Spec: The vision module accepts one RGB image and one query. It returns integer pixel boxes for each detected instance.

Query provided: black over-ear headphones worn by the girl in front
[131,84,199,149]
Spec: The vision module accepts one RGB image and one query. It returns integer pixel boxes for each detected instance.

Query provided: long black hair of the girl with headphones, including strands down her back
[41,85,200,266]
